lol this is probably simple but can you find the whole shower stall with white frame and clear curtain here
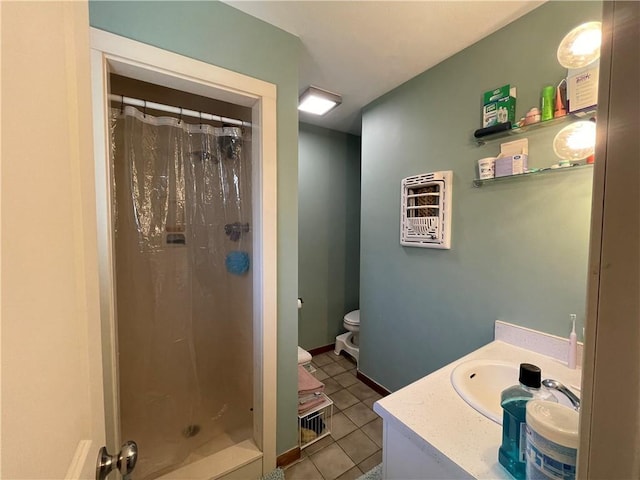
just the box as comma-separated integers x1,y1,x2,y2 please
90,28,277,480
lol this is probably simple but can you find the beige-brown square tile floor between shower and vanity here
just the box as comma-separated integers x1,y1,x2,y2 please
284,352,382,480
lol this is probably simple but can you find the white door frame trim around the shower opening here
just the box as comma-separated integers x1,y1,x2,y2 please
90,28,277,472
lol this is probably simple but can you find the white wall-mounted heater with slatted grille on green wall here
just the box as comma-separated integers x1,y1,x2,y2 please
400,171,453,249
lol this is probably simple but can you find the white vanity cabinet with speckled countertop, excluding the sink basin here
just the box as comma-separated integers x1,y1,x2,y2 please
373,324,581,480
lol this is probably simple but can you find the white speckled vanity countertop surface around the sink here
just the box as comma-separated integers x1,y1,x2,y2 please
373,340,581,479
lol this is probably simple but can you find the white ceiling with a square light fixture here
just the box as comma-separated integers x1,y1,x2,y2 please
225,0,544,135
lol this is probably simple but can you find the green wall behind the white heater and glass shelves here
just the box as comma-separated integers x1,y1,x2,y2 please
360,2,602,390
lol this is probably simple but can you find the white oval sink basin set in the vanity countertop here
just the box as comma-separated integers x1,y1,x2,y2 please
451,360,519,425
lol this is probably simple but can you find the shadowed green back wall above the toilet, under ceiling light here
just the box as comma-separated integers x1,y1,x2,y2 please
298,123,360,349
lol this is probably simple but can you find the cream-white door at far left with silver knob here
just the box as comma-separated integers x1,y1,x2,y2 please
0,1,111,479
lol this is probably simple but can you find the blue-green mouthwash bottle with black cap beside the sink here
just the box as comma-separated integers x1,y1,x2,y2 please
498,363,557,480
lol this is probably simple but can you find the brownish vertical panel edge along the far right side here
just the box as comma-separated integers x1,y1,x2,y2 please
578,2,640,479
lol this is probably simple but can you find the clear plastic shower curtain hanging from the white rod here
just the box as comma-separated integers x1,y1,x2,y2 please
112,107,253,479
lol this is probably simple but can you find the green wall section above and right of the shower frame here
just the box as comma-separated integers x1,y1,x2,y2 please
89,1,300,454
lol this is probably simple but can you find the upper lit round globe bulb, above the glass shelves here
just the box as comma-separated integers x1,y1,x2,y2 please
557,22,602,69
